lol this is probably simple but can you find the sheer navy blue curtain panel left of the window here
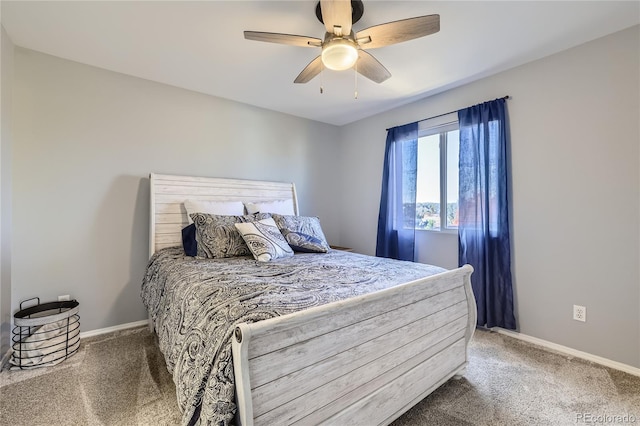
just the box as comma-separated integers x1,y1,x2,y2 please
376,122,418,261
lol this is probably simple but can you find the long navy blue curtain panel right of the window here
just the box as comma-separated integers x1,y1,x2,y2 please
458,99,516,330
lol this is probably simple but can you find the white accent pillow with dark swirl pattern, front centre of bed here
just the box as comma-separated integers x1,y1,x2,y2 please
235,218,293,262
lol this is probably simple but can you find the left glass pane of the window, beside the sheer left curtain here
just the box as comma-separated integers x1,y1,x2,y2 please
416,134,440,229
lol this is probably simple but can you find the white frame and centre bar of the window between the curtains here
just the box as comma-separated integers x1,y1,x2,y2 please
415,113,460,234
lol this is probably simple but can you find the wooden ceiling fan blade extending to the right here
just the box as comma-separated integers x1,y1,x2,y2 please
356,15,440,49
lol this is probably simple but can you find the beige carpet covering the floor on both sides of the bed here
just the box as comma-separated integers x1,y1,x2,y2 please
0,328,640,426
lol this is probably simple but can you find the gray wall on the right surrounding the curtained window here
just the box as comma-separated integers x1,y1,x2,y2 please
340,26,640,367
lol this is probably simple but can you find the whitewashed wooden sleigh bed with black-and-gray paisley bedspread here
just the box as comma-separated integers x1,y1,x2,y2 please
142,173,476,425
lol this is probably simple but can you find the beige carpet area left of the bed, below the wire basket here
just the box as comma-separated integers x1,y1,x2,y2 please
0,328,180,426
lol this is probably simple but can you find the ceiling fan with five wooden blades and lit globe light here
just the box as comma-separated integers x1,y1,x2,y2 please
244,0,440,83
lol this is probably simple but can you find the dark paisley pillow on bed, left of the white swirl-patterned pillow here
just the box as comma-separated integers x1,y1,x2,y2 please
191,213,271,259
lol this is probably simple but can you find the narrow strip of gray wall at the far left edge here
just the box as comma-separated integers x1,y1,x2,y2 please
0,26,13,360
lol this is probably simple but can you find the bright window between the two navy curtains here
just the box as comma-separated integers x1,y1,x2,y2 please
415,121,460,231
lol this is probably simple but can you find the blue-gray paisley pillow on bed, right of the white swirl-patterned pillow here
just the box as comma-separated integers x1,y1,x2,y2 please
272,214,329,253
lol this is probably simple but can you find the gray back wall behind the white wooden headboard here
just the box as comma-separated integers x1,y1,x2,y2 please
12,47,340,331
